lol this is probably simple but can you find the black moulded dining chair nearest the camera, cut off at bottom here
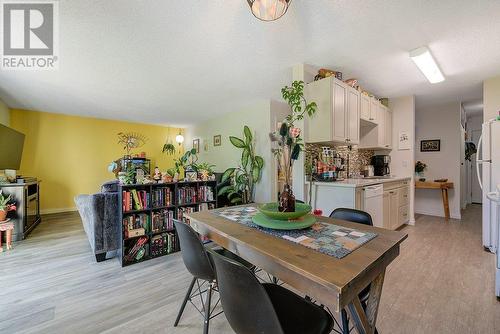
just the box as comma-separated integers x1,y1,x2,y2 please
210,251,333,334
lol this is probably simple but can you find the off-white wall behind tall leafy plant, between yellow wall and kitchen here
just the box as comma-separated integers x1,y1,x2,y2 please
185,100,275,202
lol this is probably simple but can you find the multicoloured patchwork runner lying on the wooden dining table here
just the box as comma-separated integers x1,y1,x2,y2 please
211,206,377,259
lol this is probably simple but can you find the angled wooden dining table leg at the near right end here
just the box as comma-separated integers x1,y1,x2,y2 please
347,270,385,334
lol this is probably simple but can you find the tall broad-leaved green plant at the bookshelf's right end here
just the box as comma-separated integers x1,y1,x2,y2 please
219,125,264,204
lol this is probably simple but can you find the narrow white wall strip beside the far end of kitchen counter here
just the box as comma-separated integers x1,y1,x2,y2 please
389,96,415,225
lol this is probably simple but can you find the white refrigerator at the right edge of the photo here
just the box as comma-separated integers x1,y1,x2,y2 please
476,120,500,296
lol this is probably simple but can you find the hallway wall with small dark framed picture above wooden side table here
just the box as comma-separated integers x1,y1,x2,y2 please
415,103,461,219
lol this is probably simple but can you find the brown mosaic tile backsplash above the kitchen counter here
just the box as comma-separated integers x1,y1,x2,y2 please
305,144,374,178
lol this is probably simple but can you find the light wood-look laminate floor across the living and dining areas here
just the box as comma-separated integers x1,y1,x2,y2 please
0,206,500,334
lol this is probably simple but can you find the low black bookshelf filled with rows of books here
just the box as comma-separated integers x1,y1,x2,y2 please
119,181,217,267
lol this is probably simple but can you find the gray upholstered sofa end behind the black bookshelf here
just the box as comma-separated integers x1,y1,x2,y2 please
75,181,121,262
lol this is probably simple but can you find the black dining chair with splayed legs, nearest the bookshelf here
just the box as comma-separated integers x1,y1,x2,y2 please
174,220,254,334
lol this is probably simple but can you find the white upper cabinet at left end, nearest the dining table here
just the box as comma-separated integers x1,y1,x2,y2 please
306,77,360,145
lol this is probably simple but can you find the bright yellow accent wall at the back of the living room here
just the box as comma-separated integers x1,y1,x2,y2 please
10,109,184,213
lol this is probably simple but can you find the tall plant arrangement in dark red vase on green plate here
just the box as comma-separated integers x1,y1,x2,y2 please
269,81,317,212
